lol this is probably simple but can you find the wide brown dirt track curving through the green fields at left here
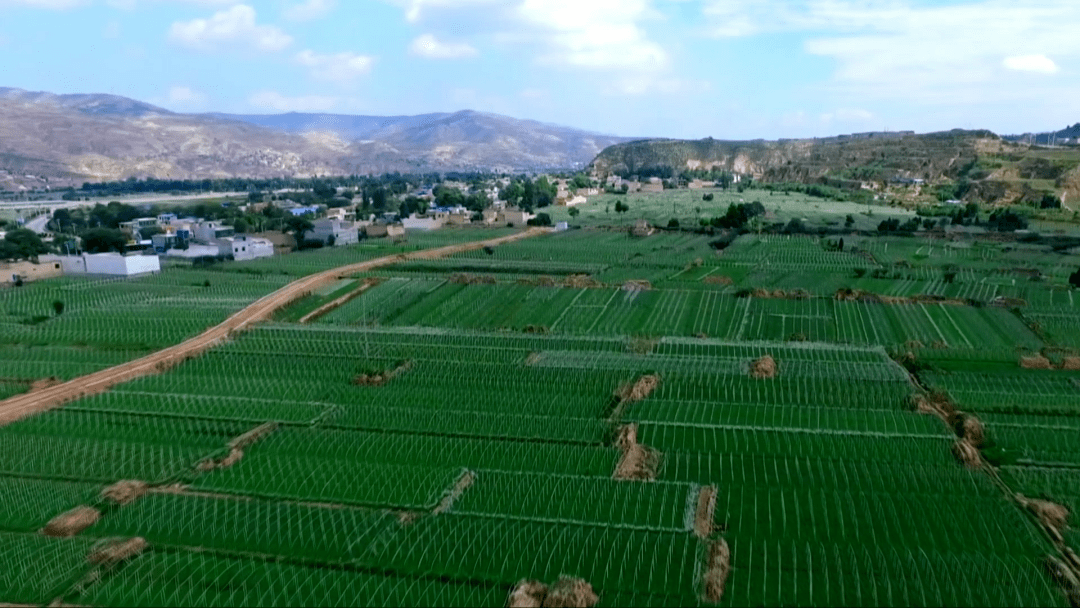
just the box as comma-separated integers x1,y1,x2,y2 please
0,228,549,427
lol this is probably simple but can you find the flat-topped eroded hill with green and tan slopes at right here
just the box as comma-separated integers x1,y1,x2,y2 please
592,130,1080,204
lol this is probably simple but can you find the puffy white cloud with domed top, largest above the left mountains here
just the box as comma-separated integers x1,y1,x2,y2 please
168,4,293,52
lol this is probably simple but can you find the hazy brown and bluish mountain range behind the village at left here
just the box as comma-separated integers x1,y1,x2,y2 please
0,87,630,190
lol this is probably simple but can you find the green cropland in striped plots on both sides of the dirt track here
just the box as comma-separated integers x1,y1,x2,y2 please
0,226,1080,606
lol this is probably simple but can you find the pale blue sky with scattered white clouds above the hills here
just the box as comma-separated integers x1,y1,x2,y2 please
0,0,1080,139
